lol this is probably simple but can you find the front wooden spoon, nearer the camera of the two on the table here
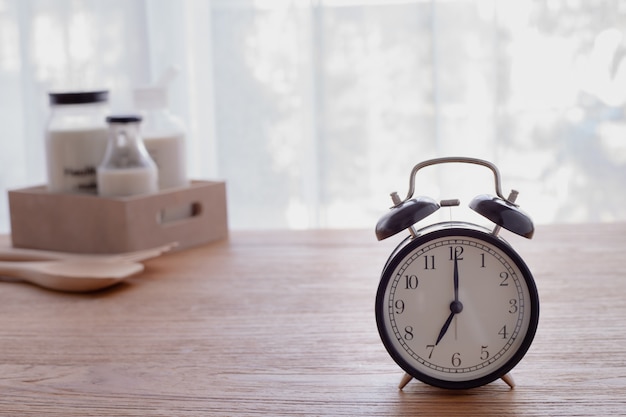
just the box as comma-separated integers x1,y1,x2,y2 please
0,260,144,292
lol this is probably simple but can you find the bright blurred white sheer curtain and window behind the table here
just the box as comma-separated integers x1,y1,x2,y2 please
0,0,626,233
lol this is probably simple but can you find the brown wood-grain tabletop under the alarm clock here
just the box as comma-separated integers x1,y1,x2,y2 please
0,224,626,417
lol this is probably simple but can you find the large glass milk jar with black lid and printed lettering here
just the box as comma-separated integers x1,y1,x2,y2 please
46,90,109,194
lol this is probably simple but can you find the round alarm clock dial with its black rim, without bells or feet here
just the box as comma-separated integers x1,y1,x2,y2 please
376,225,539,388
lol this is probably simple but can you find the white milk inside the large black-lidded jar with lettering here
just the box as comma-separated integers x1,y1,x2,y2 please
46,126,108,193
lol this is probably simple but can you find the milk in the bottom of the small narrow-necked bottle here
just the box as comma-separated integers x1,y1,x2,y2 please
98,167,158,197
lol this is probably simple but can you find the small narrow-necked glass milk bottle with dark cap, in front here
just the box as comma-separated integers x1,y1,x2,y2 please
97,115,158,197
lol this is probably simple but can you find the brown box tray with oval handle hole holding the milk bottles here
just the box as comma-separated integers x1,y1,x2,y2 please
9,181,228,253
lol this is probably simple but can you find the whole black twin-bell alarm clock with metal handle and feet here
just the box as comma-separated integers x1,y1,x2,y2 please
375,157,539,389
